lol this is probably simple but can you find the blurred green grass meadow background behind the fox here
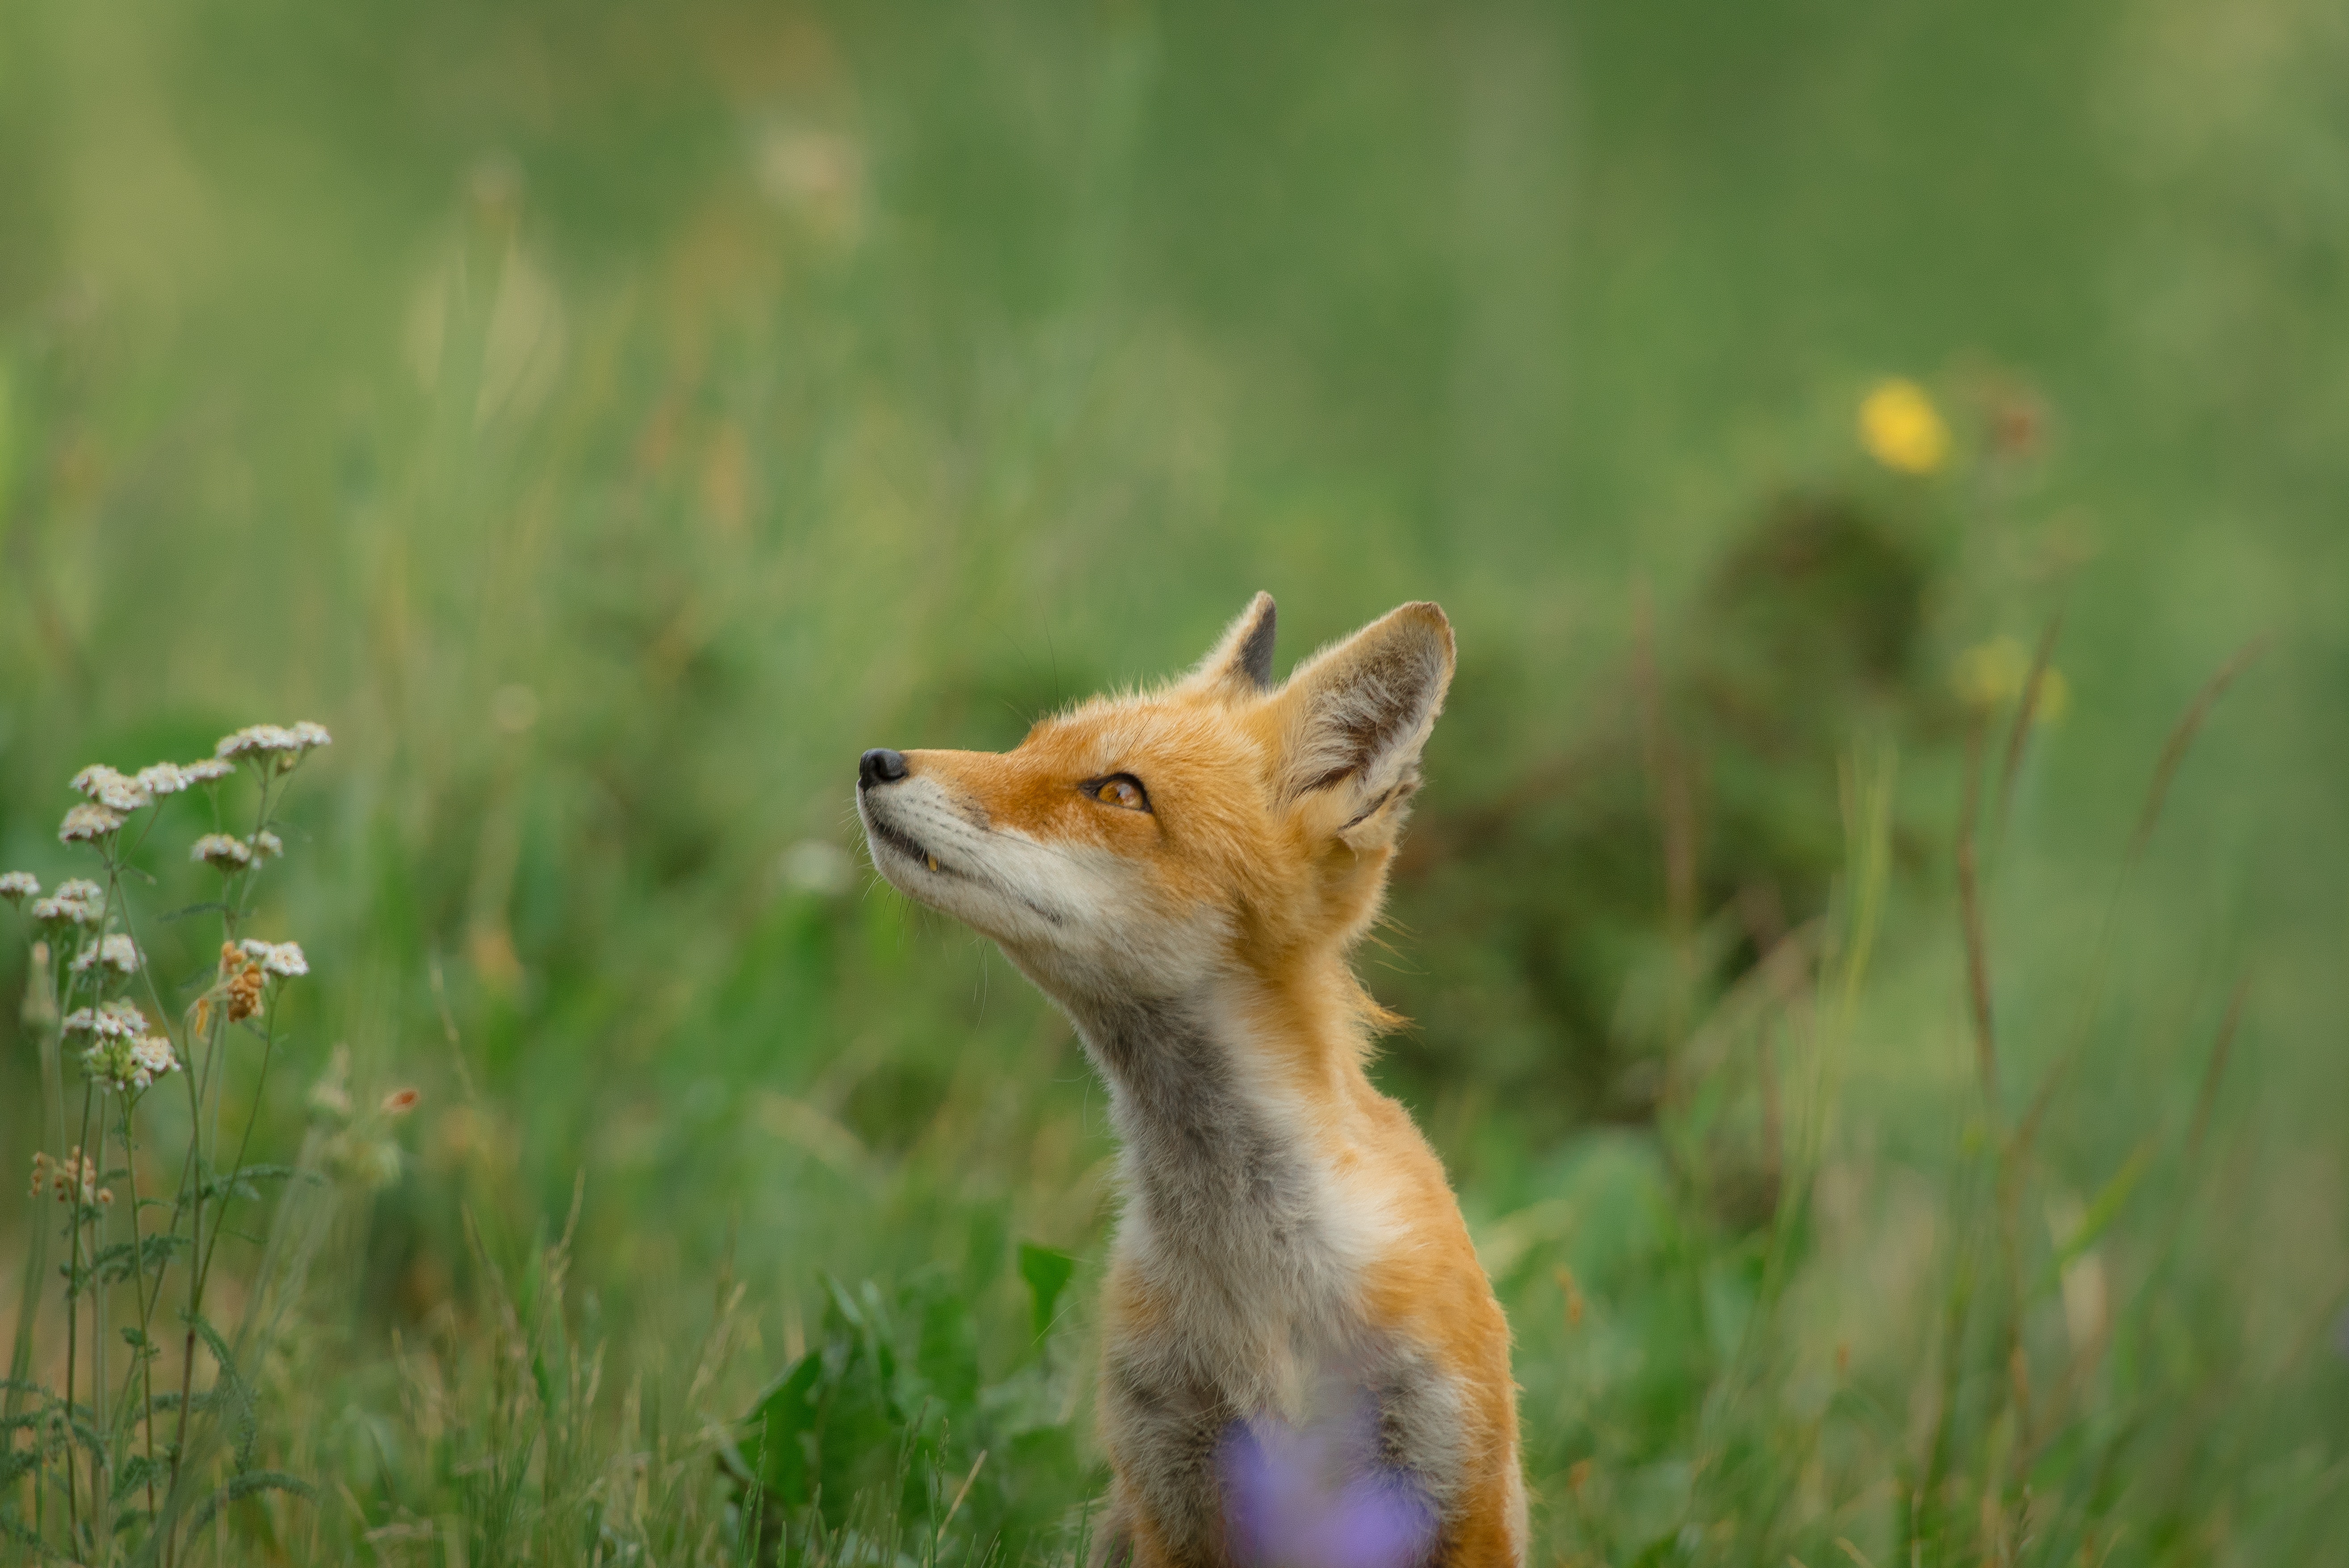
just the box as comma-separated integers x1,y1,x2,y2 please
0,0,2349,1568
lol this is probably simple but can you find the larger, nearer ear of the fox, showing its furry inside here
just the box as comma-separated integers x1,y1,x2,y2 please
1280,603,1454,840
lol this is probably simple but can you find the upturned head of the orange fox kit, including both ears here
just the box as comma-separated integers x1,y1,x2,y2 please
857,594,1454,1009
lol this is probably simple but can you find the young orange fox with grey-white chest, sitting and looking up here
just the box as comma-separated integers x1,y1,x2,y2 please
857,594,1524,1568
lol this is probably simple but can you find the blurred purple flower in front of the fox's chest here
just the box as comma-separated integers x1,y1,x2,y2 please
1217,1404,1435,1568
